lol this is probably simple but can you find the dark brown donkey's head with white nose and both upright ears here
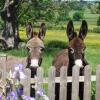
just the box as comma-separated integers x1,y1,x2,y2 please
67,20,88,67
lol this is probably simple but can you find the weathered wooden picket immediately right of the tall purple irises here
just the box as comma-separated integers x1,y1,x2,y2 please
23,69,31,96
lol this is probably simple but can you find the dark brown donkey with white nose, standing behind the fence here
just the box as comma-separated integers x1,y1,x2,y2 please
52,20,88,100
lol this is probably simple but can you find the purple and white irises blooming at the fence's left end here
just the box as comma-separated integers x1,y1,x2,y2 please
0,64,49,100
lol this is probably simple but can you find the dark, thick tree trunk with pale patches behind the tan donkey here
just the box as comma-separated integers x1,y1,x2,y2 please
1,0,19,48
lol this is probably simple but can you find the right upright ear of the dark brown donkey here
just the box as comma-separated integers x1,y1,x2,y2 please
79,20,88,40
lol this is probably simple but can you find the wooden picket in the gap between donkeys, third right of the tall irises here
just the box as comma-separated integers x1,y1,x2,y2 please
48,67,55,100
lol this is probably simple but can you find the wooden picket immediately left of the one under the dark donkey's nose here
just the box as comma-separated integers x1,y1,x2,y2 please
59,66,67,100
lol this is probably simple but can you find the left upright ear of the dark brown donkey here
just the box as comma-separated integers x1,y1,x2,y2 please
66,20,77,41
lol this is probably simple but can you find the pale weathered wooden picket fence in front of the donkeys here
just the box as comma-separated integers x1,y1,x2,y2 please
2,56,100,100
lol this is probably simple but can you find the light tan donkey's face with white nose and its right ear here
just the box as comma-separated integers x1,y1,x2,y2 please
26,23,46,67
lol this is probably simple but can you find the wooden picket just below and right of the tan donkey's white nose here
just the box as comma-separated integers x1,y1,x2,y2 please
35,67,43,100
